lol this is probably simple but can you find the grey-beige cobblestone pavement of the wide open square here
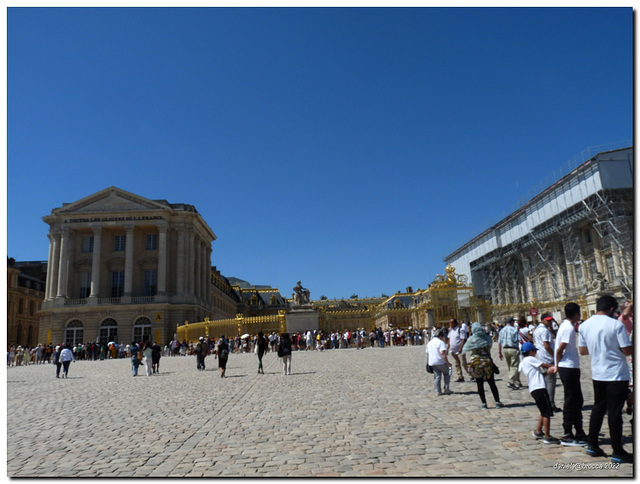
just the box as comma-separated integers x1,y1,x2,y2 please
7,346,633,477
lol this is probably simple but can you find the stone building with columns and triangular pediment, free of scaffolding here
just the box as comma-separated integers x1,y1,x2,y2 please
39,187,225,344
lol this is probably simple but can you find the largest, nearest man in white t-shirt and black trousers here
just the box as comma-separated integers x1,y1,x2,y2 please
578,295,633,463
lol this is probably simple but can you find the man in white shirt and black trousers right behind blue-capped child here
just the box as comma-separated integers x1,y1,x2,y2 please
556,303,587,446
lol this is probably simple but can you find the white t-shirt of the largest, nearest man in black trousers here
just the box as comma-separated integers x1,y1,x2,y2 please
578,314,631,381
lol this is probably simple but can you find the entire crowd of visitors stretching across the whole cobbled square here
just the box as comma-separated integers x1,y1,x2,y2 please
7,296,633,462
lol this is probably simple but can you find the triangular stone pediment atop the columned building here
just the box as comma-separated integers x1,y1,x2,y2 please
53,187,172,215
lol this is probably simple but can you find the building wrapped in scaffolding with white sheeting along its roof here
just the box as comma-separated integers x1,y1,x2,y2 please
444,147,634,320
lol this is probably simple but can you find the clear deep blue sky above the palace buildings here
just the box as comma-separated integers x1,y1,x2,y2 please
7,8,633,299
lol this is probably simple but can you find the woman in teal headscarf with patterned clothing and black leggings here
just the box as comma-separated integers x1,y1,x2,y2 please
462,323,504,410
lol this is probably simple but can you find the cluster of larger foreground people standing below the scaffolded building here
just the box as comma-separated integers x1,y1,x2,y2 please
426,295,633,463
